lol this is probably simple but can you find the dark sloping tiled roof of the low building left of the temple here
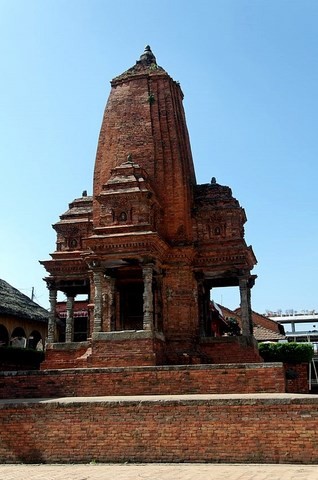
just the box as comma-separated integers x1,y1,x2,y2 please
0,279,49,323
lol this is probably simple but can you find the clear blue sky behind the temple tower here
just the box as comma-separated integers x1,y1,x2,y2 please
0,0,318,313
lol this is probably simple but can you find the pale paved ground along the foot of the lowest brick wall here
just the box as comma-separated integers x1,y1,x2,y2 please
0,462,317,480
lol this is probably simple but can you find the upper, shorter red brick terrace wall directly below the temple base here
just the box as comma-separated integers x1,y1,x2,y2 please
0,363,285,399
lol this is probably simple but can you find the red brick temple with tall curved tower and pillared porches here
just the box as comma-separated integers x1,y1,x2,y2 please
41,46,260,368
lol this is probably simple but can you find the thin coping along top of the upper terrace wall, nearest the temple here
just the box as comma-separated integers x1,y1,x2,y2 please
0,362,283,377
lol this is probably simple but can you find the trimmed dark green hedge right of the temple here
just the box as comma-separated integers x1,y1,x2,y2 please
259,342,314,363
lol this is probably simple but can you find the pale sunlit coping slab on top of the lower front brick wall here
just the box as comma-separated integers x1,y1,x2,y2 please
0,393,318,409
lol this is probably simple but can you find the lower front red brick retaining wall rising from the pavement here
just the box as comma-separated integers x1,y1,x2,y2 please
0,395,318,464
